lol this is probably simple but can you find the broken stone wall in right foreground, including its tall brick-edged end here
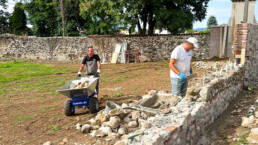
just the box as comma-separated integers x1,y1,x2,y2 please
114,24,258,145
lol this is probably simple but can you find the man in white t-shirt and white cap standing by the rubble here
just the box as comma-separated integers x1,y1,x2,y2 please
169,37,198,97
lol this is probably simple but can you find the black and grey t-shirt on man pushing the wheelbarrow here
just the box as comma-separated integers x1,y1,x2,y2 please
82,54,100,75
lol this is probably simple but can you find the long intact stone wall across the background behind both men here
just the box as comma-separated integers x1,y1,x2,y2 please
0,34,209,62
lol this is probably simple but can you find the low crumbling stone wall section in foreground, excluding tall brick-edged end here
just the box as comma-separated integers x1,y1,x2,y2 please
116,67,244,145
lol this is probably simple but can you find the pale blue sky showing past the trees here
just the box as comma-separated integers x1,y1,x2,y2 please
2,0,258,29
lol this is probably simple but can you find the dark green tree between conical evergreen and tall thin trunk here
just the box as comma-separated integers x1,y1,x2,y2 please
26,0,62,37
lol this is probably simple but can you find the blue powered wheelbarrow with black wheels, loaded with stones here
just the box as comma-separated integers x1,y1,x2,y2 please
56,77,99,116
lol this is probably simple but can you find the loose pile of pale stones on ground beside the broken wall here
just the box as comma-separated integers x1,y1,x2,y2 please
75,90,180,139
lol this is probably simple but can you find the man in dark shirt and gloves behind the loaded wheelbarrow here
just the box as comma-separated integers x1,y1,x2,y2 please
78,46,101,97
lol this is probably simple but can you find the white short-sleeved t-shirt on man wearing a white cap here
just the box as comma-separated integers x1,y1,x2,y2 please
170,45,192,78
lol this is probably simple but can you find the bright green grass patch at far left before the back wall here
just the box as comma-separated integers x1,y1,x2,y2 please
0,61,70,82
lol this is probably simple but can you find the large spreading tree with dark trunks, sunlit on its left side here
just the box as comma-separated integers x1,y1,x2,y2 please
80,0,209,35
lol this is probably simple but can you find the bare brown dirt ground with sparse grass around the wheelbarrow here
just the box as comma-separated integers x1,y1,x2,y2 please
0,61,222,145
